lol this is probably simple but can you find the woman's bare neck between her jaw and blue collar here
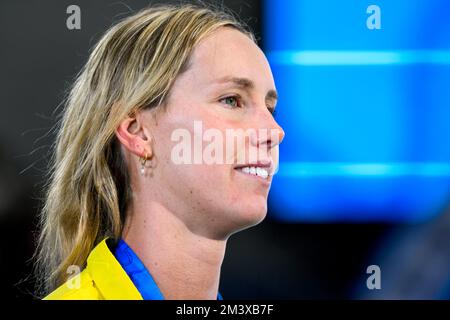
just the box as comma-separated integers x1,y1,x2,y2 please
122,202,226,300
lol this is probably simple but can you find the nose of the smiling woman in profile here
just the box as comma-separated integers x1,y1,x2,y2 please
252,108,285,149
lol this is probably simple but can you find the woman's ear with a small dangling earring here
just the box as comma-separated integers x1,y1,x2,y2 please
115,111,153,158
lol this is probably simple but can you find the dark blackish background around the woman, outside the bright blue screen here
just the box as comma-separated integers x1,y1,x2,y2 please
0,0,450,299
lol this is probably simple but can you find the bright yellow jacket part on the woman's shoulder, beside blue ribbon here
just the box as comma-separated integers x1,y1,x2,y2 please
44,239,142,300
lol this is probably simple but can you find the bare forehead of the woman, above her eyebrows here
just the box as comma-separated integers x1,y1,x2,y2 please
183,27,275,90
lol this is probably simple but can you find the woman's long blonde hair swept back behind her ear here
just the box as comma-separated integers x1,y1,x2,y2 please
35,5,255,294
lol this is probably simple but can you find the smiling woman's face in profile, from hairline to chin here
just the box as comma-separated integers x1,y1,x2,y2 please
145,27,284,239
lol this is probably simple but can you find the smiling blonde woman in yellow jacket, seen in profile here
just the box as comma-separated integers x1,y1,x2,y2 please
37,5,284,299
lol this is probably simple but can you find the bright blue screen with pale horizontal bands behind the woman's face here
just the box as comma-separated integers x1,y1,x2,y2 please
263,0,450,222
